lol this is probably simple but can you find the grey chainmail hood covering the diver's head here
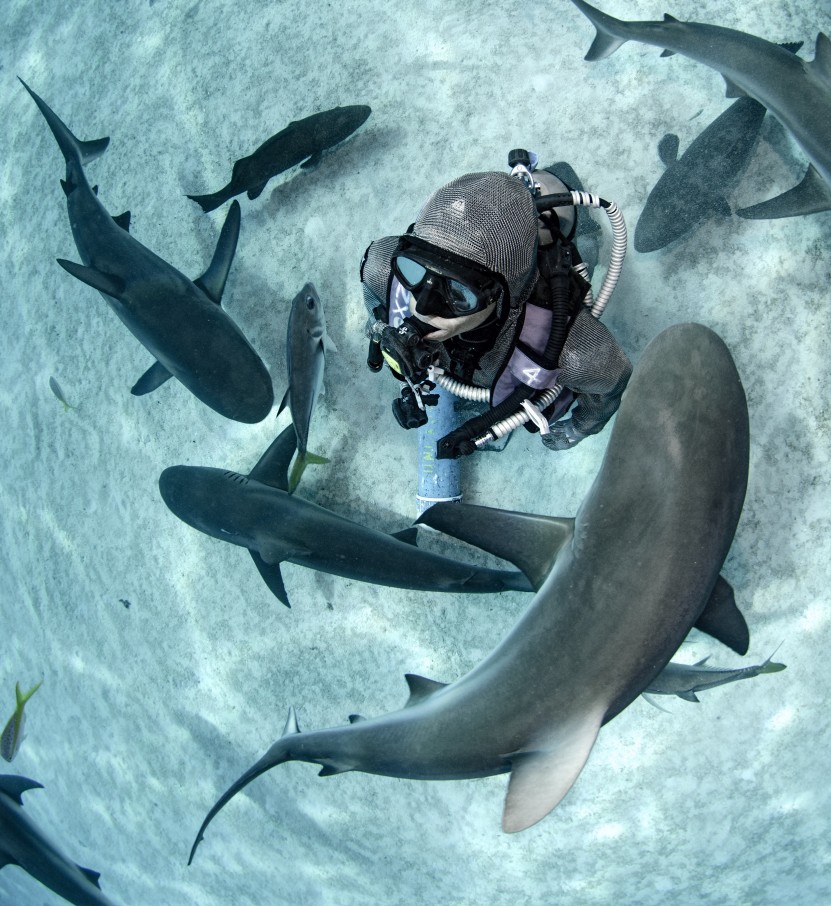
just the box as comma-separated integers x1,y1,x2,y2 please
413,172,538,308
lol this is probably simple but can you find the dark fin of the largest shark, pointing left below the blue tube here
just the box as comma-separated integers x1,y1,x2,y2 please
416,503,574,589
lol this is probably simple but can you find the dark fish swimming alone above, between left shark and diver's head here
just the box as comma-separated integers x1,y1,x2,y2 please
188,104,372,211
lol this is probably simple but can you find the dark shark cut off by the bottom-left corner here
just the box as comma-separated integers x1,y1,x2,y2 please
0,774,120,906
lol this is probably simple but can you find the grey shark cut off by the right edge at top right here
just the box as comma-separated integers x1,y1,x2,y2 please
572,0,831,219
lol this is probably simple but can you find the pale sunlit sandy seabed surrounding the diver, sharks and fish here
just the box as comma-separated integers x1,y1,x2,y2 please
0,0,831,906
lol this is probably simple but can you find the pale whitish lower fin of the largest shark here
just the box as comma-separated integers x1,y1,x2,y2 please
502,707,606,834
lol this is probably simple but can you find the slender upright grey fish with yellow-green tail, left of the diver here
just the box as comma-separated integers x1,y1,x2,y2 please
278,283,337,493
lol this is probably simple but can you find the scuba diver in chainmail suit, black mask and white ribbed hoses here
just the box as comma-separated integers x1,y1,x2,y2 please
360,149,632,459
